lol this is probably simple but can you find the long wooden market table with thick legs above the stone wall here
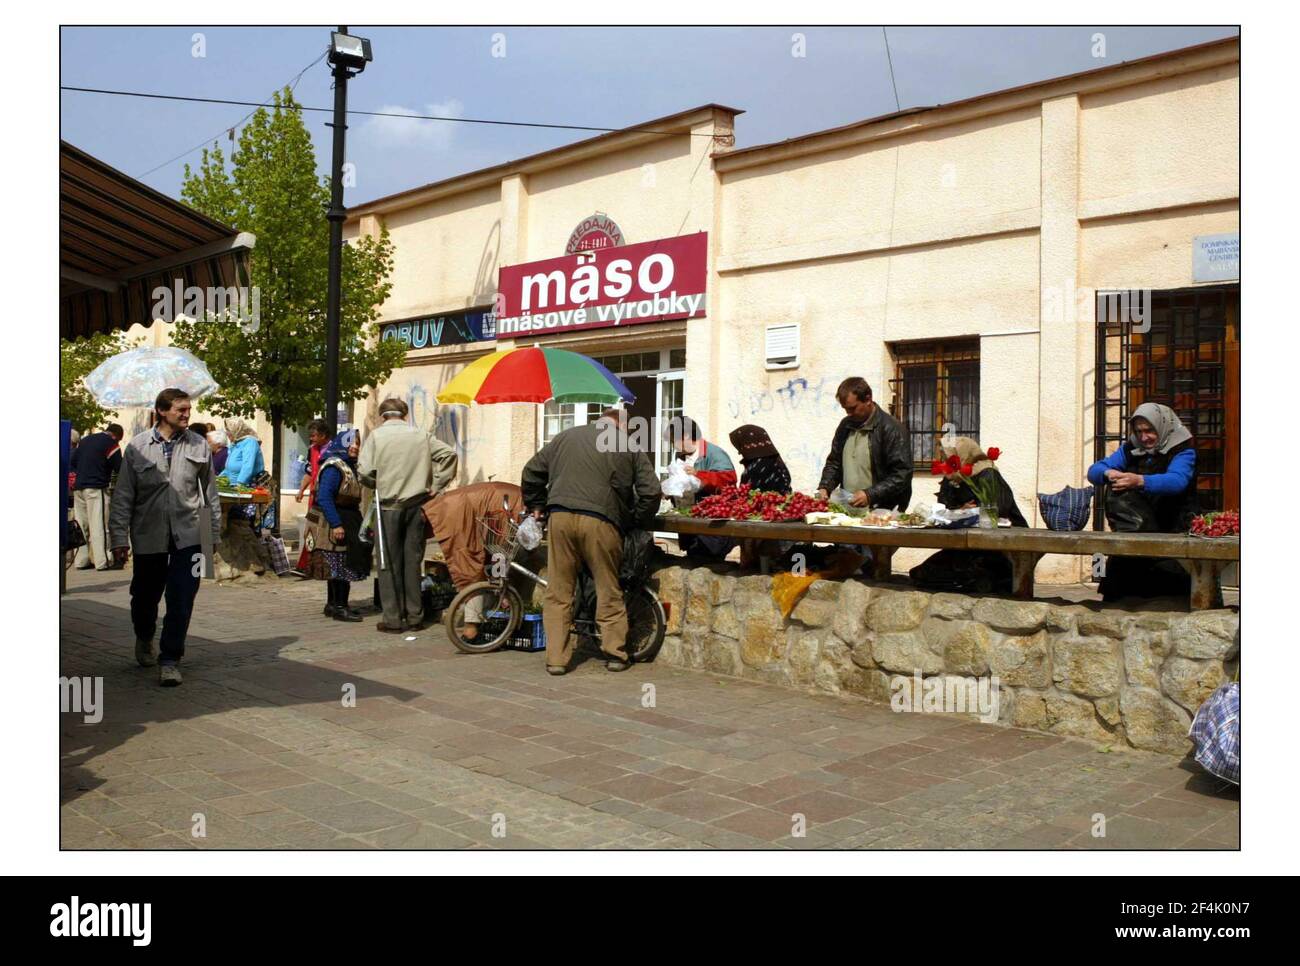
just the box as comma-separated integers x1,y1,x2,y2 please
654,514,1242,610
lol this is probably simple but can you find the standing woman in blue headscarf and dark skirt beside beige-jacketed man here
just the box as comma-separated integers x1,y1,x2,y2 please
306,429,371,623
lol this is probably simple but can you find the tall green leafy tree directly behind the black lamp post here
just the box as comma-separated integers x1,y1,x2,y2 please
172,87,406,491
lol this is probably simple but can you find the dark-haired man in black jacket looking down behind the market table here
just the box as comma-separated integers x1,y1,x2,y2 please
818,376,913,510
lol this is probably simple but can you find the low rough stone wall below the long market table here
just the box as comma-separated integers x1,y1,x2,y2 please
655,562,1239,754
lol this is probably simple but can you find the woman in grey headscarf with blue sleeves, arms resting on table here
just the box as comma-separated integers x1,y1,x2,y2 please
1088,403,1200,601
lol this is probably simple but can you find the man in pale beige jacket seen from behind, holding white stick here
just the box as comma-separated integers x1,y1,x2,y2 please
356,399,458,633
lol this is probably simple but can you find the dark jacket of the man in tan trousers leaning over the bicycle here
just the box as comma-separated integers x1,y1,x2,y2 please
523,419,660,533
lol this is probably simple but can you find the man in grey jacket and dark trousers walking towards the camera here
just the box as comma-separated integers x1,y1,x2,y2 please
108,389,221,686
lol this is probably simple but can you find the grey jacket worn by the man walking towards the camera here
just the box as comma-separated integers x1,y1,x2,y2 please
108,429,221,554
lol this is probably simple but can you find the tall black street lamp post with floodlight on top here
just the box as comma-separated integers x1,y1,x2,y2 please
324,26,371,436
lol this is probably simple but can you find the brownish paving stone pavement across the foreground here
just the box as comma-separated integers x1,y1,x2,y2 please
60,569,1239,849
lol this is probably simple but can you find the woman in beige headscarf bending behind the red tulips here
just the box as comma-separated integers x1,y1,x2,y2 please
911,436,1030,594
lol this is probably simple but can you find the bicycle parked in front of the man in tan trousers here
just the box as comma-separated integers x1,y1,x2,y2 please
443,508,668,662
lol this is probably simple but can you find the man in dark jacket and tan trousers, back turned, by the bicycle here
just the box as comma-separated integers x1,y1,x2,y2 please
521,410,659,675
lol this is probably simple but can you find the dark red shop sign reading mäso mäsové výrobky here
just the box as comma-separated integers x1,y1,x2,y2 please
497,231,709,339
